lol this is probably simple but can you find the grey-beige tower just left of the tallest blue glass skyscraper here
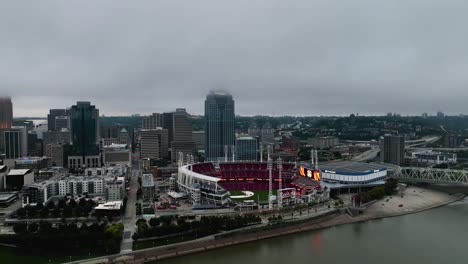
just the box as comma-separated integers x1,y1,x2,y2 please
169,108,195,161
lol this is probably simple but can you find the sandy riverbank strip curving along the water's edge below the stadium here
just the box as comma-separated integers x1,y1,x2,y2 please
77,187,463,263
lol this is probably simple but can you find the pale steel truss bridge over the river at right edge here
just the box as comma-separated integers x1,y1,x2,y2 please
392,167,468,186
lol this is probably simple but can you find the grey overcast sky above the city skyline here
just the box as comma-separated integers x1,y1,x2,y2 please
0,0,468,117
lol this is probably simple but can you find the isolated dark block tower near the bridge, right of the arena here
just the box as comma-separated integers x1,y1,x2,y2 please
380,135,405,165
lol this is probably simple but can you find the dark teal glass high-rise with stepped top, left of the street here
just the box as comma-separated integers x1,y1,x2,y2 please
69,102,99,159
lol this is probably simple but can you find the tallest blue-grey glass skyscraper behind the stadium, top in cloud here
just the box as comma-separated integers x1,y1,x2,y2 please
205,92,236,161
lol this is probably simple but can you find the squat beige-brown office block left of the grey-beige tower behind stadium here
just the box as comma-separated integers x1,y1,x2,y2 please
140,128,169,159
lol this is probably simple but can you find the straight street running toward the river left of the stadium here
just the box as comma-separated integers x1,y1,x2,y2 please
120,155,141,254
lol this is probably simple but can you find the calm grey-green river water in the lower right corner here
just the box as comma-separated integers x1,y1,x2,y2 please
158,202,468,264
